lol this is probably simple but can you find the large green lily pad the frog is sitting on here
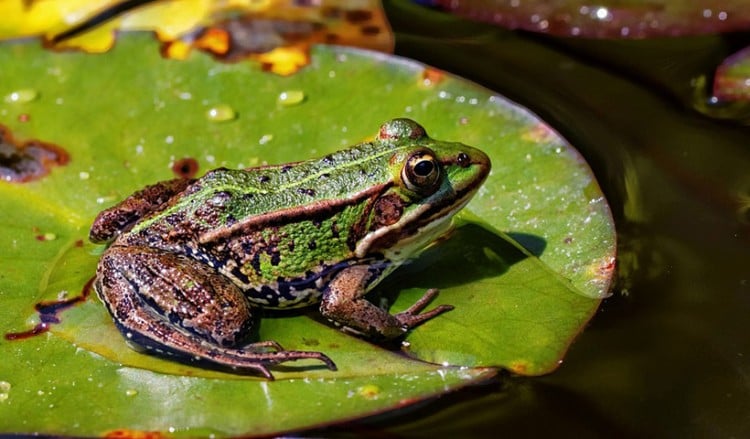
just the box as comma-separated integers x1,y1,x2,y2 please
0,35,615,436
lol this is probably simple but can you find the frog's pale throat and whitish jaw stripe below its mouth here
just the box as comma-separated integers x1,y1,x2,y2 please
354,190,475,262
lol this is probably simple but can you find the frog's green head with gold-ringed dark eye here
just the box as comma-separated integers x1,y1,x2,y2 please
356,119,490,261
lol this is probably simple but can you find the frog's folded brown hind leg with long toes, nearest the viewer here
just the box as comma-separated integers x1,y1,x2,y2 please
94,246,336,379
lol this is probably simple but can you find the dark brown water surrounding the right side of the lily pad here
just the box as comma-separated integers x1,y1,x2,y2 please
327,1,750,437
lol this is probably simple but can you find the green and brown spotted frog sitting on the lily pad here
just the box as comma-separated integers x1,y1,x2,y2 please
89,118,491,380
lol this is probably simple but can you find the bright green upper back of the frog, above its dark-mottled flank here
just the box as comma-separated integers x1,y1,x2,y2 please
133,142,398,237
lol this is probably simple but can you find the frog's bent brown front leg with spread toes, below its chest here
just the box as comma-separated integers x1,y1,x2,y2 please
320,265,453,339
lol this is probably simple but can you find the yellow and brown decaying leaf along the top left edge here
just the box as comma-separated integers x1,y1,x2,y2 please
0,0,393,75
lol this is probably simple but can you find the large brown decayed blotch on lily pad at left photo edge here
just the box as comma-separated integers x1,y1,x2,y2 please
0,125,70,183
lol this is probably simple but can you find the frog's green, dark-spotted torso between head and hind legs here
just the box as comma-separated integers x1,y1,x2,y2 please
122,142,402,307
